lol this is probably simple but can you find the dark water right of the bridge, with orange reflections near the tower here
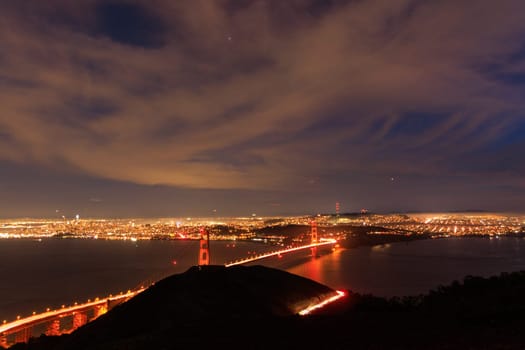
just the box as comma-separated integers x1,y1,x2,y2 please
288,238,525,296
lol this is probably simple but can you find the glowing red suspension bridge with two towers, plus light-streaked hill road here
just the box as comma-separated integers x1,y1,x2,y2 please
0,221,344,348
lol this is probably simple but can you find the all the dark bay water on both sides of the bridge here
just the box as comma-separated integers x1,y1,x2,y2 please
0,238,525,321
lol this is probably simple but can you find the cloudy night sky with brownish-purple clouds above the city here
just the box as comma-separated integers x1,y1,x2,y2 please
0,0,525,217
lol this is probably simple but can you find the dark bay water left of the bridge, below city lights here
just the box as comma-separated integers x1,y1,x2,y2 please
0,239,274,322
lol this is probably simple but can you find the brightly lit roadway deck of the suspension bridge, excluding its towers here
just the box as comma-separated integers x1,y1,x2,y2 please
0,239,336,345
